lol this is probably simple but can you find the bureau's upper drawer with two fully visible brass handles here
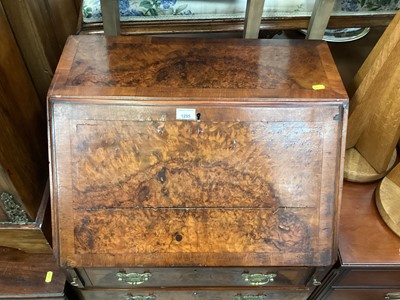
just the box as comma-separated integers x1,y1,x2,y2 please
81,267,313,287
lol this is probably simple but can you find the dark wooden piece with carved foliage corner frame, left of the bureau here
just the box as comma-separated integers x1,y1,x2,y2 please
0,2,51,253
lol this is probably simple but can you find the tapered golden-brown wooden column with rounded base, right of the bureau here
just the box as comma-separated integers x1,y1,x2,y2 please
345,13,400,182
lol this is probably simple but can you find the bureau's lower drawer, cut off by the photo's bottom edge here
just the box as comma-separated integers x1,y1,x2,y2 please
81,289,307,300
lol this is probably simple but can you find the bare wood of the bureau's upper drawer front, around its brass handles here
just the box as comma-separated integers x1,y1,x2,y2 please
80,267,315,288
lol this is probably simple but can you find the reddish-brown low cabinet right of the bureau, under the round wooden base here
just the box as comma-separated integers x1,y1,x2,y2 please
312,182,400,300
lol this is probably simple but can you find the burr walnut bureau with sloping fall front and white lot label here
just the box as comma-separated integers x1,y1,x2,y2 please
48,36,348,300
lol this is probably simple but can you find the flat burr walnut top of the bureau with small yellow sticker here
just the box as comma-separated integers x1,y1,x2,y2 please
49,36,347,102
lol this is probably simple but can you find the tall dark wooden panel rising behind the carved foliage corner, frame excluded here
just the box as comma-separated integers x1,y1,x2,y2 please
0,3,47,221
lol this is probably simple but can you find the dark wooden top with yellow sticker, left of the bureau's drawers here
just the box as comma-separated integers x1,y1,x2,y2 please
0,247,66,300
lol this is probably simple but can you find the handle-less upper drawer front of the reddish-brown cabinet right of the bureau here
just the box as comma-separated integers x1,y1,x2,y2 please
334,269,400,288
